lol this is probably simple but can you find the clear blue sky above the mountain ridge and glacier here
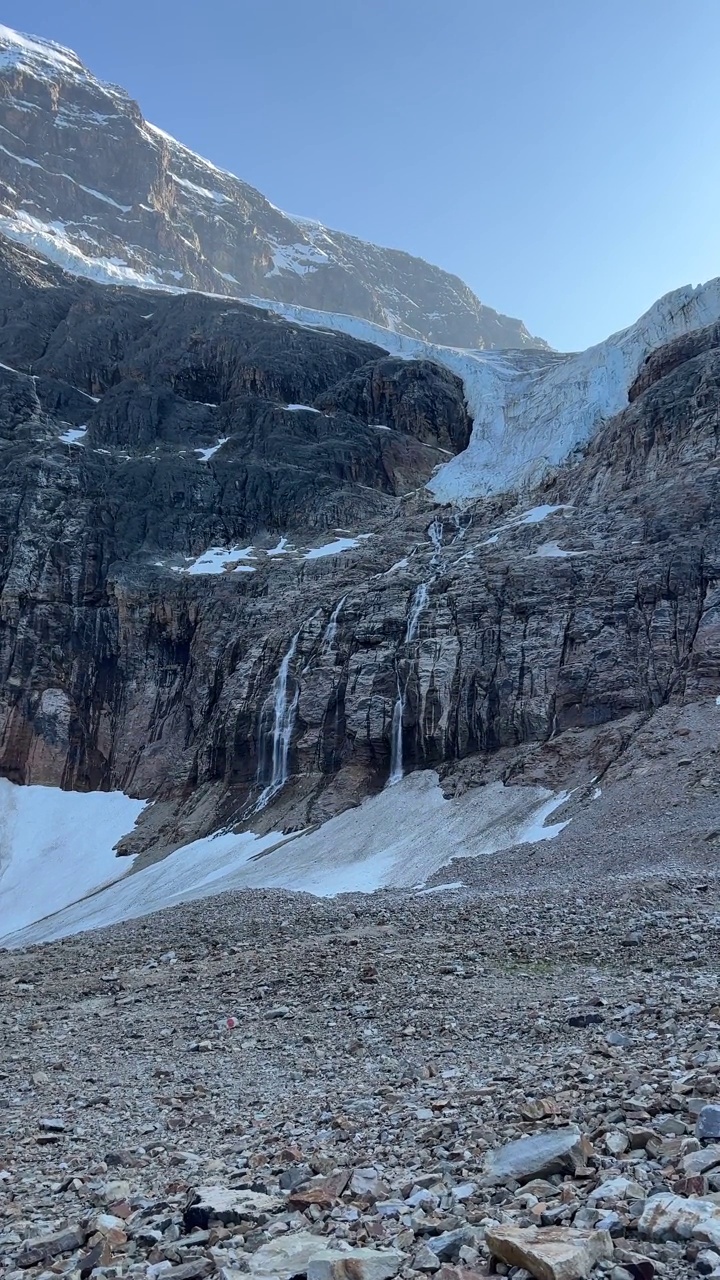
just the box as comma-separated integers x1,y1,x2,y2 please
0,0,720,349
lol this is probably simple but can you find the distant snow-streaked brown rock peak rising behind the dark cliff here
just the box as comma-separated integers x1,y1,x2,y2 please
0,27,547,348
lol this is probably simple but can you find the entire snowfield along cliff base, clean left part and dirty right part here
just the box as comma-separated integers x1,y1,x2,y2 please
0,769,568,946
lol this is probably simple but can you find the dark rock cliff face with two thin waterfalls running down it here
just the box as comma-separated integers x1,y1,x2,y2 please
0,246,720,847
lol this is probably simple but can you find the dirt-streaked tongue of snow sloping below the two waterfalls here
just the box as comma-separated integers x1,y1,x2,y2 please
0,769,568,946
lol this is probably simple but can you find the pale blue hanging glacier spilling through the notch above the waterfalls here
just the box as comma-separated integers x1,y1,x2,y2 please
258,278,720,503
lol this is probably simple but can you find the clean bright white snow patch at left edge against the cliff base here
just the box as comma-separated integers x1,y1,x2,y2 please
0,778,145,934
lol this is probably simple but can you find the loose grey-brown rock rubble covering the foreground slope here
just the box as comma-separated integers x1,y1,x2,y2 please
0,859,720,1280
